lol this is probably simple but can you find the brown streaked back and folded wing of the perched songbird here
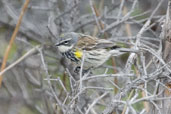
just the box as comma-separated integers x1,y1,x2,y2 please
76,34,118,50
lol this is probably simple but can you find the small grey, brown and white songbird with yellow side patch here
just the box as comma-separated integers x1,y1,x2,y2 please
56,32,135,69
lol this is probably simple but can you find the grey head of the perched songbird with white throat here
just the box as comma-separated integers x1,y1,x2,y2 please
55,32,79,53
